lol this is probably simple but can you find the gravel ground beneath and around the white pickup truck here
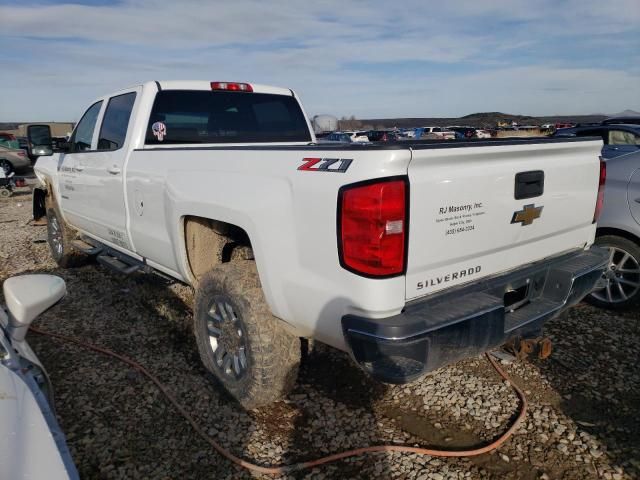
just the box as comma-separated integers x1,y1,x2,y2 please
0,191,640,480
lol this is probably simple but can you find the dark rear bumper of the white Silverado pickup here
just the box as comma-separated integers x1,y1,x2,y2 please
342,247,609,383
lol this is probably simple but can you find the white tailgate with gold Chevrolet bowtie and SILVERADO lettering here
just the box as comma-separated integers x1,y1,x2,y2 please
406,140,602,299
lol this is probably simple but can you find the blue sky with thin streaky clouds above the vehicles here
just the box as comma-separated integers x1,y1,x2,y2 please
0,0,640,121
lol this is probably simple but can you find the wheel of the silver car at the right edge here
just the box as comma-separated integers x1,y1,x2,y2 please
587,235,640,310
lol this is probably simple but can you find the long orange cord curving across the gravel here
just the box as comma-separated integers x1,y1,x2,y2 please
30,327,527,475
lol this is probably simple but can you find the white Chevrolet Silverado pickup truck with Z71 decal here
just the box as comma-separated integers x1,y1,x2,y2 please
30,81,607,408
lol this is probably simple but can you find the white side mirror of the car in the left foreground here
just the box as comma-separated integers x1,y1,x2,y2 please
2,275,67,342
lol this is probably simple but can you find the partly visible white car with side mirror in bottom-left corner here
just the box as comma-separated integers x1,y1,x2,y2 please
0,275,79,480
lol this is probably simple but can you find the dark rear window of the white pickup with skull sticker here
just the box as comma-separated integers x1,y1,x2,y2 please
146,90,311,145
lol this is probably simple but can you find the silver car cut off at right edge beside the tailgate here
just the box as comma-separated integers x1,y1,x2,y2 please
587,149,640,309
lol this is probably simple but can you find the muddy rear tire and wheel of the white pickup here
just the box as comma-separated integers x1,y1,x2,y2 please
194,260,300,410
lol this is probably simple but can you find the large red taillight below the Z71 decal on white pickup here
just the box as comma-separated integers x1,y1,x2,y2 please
338,177,409,278
